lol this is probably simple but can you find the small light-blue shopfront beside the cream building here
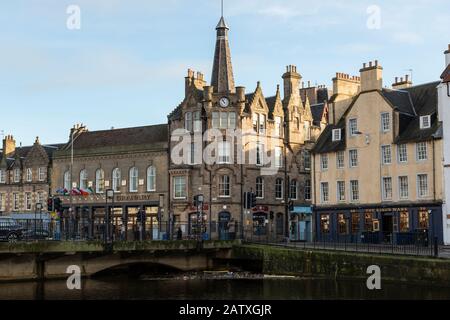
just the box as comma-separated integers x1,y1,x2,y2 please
289,206,312,242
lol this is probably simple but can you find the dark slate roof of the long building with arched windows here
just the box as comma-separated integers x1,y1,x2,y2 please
66,124,168,149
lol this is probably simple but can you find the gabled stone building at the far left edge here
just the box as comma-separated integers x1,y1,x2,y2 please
0,135,61,215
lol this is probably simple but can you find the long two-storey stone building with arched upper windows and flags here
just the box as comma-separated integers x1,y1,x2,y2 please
52,124,168,239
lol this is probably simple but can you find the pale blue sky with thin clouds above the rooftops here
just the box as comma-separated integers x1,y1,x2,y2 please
0,0,450,145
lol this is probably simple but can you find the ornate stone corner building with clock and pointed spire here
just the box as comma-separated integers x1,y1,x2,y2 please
168,17,328,239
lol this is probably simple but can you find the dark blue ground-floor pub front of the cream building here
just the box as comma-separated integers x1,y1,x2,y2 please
313,205,443,245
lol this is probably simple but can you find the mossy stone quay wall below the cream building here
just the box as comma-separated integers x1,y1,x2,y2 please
233,245,450,286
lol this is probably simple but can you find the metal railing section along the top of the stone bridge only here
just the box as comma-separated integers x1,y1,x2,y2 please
0,218,242,242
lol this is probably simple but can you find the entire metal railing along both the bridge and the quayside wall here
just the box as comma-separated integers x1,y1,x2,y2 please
0,218,439,256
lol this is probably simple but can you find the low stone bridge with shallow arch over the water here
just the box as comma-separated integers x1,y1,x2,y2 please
0,240,240,281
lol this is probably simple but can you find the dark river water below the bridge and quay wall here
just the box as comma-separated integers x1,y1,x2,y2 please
0,274,450,300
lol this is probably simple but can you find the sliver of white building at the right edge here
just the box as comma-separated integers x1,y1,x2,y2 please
437,44,450,244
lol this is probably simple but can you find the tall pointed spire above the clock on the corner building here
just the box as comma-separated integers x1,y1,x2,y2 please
211,0,235,93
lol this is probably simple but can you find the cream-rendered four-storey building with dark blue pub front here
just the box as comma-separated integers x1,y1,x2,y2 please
313,61,443,244
